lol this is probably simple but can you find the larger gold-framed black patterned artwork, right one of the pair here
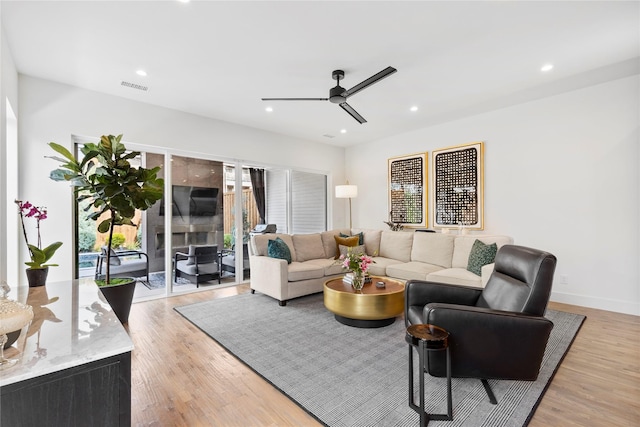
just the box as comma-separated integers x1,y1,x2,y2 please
431,142,484,230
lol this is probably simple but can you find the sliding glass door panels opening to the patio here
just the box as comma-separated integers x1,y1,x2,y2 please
75,139,327,301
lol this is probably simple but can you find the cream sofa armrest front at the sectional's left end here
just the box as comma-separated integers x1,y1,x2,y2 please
249,255,289,301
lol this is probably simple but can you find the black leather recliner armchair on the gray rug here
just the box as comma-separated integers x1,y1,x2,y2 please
404,245,556,403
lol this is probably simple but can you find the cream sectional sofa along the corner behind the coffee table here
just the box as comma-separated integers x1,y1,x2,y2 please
249,229,513,305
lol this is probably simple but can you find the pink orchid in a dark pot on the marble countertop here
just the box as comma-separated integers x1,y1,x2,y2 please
15,200,62,287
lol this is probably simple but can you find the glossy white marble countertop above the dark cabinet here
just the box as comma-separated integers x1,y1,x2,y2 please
0,279,133,386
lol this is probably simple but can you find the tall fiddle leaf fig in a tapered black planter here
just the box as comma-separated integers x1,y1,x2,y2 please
49,135,164,323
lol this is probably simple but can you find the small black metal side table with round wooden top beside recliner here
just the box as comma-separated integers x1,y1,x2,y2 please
405,324,453,427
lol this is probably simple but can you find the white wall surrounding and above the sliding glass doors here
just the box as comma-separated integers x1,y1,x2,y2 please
19,75,346,281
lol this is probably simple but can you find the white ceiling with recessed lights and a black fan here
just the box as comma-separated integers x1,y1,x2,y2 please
0,0,640,146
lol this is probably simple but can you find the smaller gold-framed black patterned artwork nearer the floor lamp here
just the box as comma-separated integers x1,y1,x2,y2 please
388,152,428,227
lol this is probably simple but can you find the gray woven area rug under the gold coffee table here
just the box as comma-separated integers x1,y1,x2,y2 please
175,294,585,427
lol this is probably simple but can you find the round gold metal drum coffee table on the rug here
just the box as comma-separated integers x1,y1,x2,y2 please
324,276,404,328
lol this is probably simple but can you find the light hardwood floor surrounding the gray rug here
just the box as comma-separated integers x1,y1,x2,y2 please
128,285,640,427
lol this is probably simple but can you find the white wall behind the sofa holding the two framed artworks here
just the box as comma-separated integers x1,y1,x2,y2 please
346,76,640,315
